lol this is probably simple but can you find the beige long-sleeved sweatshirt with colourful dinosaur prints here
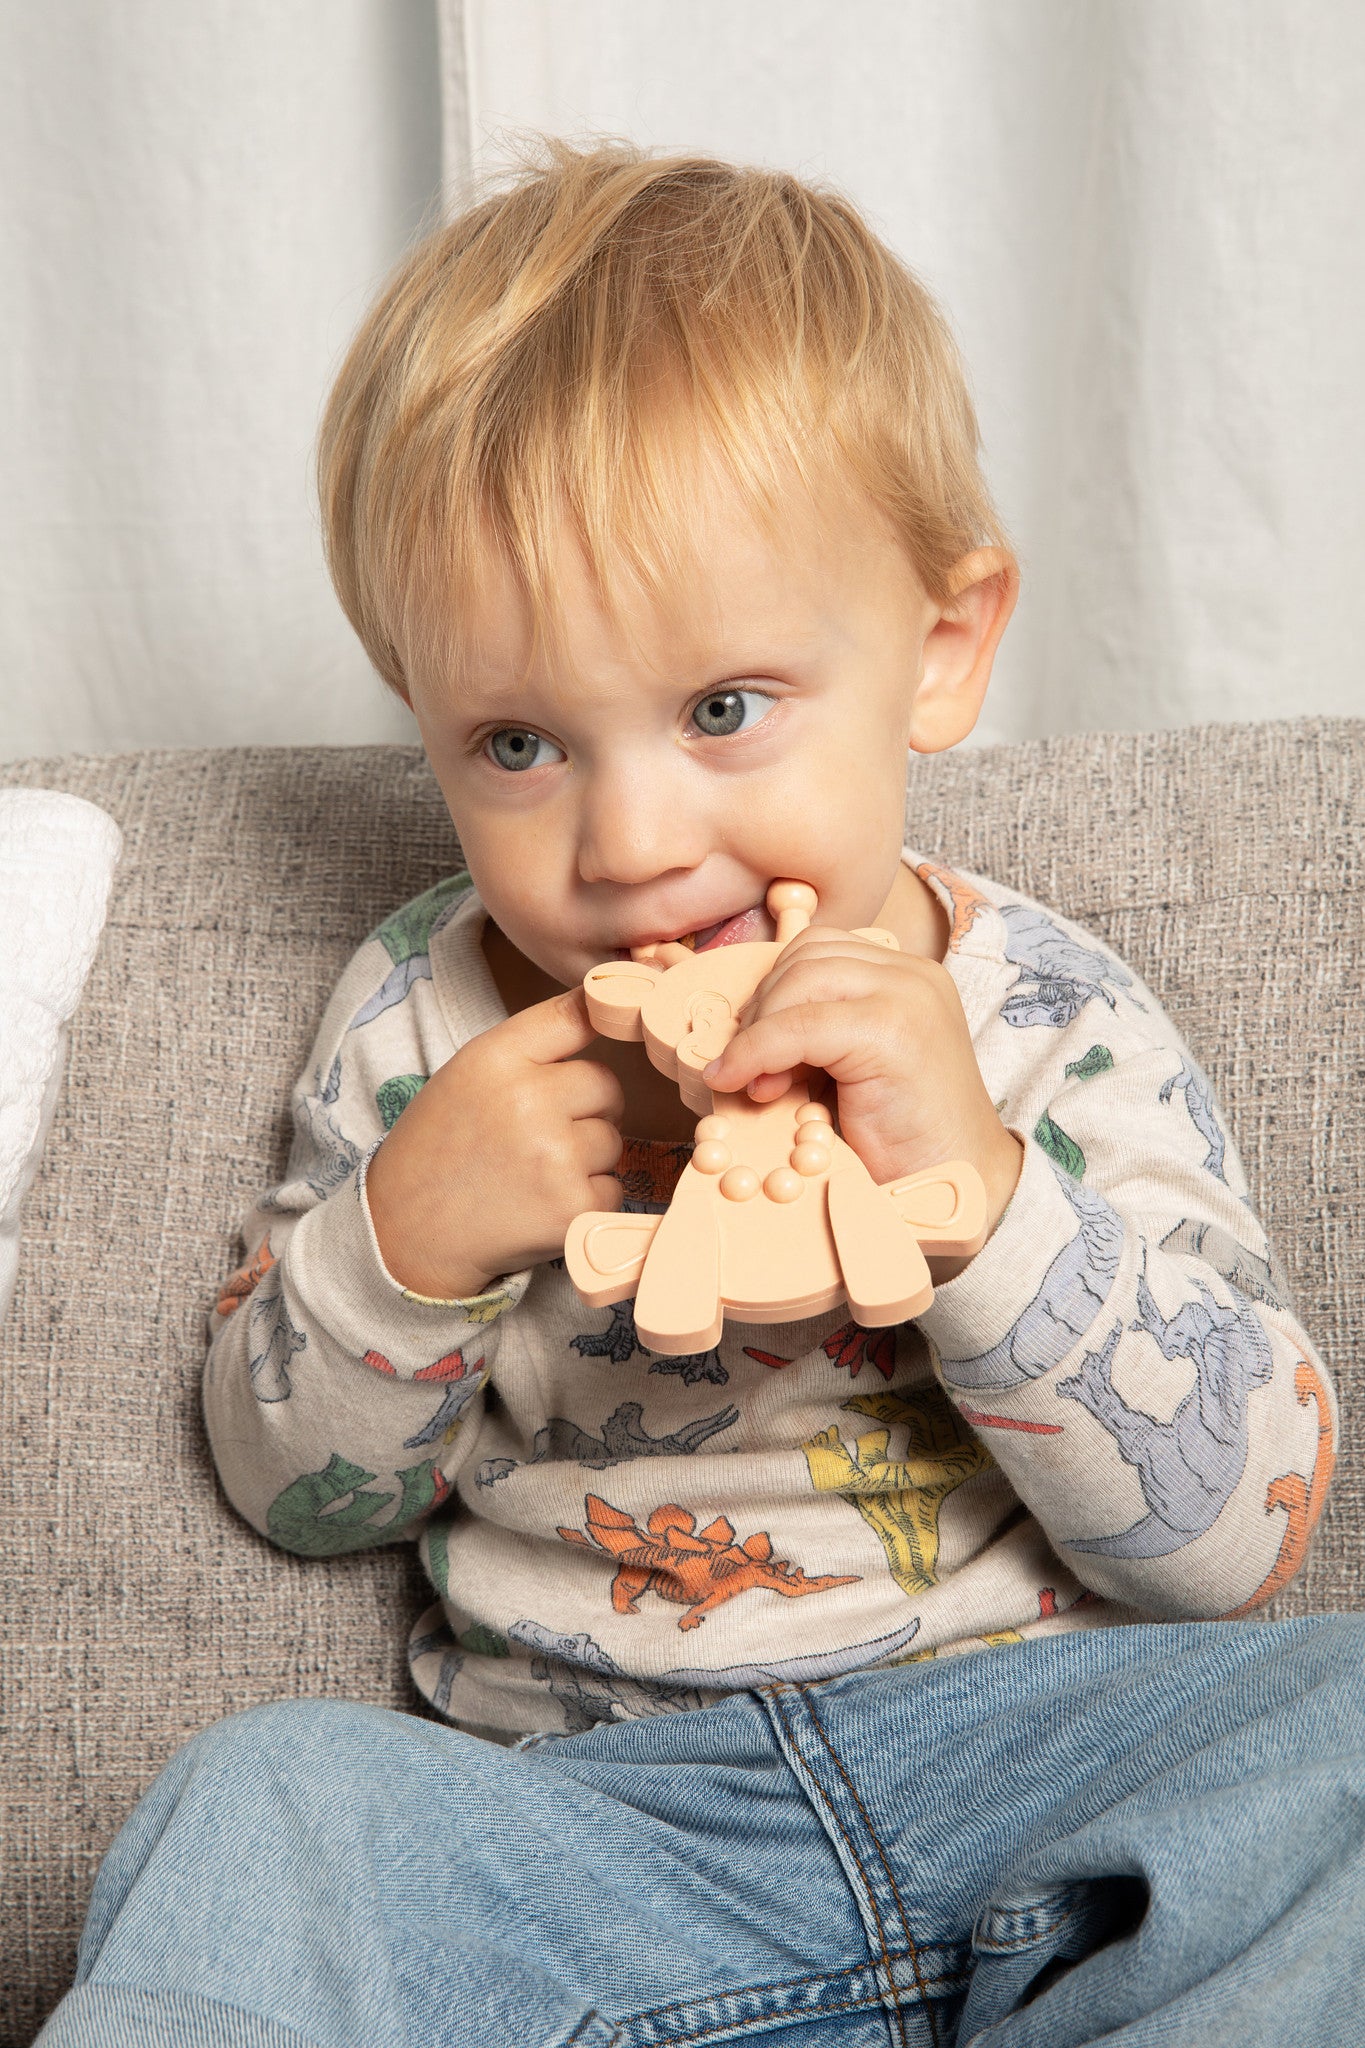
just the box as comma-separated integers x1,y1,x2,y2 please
205,850,1336,1737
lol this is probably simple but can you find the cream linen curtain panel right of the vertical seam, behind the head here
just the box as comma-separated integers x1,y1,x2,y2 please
440,0,1365,739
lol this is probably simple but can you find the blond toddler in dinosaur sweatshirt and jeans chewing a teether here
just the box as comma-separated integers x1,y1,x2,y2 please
45,143,1361,2048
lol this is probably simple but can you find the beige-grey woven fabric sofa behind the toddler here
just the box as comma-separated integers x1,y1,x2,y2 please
0,719,1365,2044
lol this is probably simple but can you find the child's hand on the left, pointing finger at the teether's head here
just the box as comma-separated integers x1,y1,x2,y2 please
366,987,626,1300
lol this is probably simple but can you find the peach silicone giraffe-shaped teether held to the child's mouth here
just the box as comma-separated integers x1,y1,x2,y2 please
565,881,986,1356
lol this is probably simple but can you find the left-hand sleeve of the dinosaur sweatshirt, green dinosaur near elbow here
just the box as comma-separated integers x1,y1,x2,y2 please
205,877,530,1556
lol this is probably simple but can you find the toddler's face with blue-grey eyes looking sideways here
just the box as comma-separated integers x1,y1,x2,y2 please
411,454,988,987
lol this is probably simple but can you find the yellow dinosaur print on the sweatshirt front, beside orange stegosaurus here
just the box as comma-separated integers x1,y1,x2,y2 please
802,1386,995,1597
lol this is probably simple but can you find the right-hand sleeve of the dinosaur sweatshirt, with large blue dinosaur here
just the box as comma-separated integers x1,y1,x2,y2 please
921,860,1336,1618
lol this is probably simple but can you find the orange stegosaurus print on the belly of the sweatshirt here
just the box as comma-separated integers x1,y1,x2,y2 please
559,1493,860,1628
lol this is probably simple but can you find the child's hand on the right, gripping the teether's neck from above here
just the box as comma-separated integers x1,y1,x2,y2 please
702,926,1023,1245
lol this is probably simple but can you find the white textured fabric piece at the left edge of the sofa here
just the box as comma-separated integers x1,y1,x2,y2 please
0,788,123,1317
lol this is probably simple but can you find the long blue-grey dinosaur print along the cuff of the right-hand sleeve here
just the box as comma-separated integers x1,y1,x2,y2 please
943,1161,1124,1389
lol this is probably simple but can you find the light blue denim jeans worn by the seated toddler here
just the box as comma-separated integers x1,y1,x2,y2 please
39,1616,1365,2048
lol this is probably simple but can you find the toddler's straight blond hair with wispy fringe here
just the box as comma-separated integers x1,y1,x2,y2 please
317,137,1005,692
